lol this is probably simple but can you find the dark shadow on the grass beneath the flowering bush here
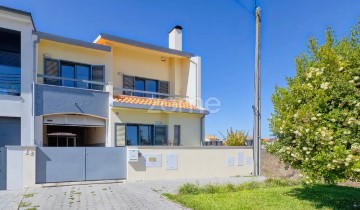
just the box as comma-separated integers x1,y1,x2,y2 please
287,185,360,209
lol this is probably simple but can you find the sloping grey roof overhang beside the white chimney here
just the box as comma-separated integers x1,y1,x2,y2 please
94,33,194,58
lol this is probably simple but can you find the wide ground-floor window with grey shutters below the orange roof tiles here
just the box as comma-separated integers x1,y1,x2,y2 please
125,124,167,145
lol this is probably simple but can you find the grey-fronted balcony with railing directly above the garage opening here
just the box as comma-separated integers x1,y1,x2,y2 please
35,74,109,119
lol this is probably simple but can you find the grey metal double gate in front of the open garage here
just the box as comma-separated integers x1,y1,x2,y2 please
36,147,126,183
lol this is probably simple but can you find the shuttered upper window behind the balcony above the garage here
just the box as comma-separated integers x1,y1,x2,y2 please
44,58,105,90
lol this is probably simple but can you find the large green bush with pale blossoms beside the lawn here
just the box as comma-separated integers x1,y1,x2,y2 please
268,23,360,183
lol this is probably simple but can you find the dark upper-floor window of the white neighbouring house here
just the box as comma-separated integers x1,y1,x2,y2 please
0,28,21,95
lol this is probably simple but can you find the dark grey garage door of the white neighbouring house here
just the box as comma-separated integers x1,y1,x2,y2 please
0,117,21,147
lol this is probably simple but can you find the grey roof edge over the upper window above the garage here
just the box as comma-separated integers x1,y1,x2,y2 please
33,31,111,52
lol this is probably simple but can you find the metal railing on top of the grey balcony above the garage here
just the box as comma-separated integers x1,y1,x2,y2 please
37,74,108,91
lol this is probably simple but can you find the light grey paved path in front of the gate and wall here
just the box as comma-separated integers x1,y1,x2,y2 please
0,177,264,210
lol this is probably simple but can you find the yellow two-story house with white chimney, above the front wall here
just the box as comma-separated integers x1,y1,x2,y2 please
34,26,207,147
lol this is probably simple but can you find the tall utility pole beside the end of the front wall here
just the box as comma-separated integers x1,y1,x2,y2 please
253,7,261,176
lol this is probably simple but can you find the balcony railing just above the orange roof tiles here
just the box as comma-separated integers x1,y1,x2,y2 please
114,87,189,101
